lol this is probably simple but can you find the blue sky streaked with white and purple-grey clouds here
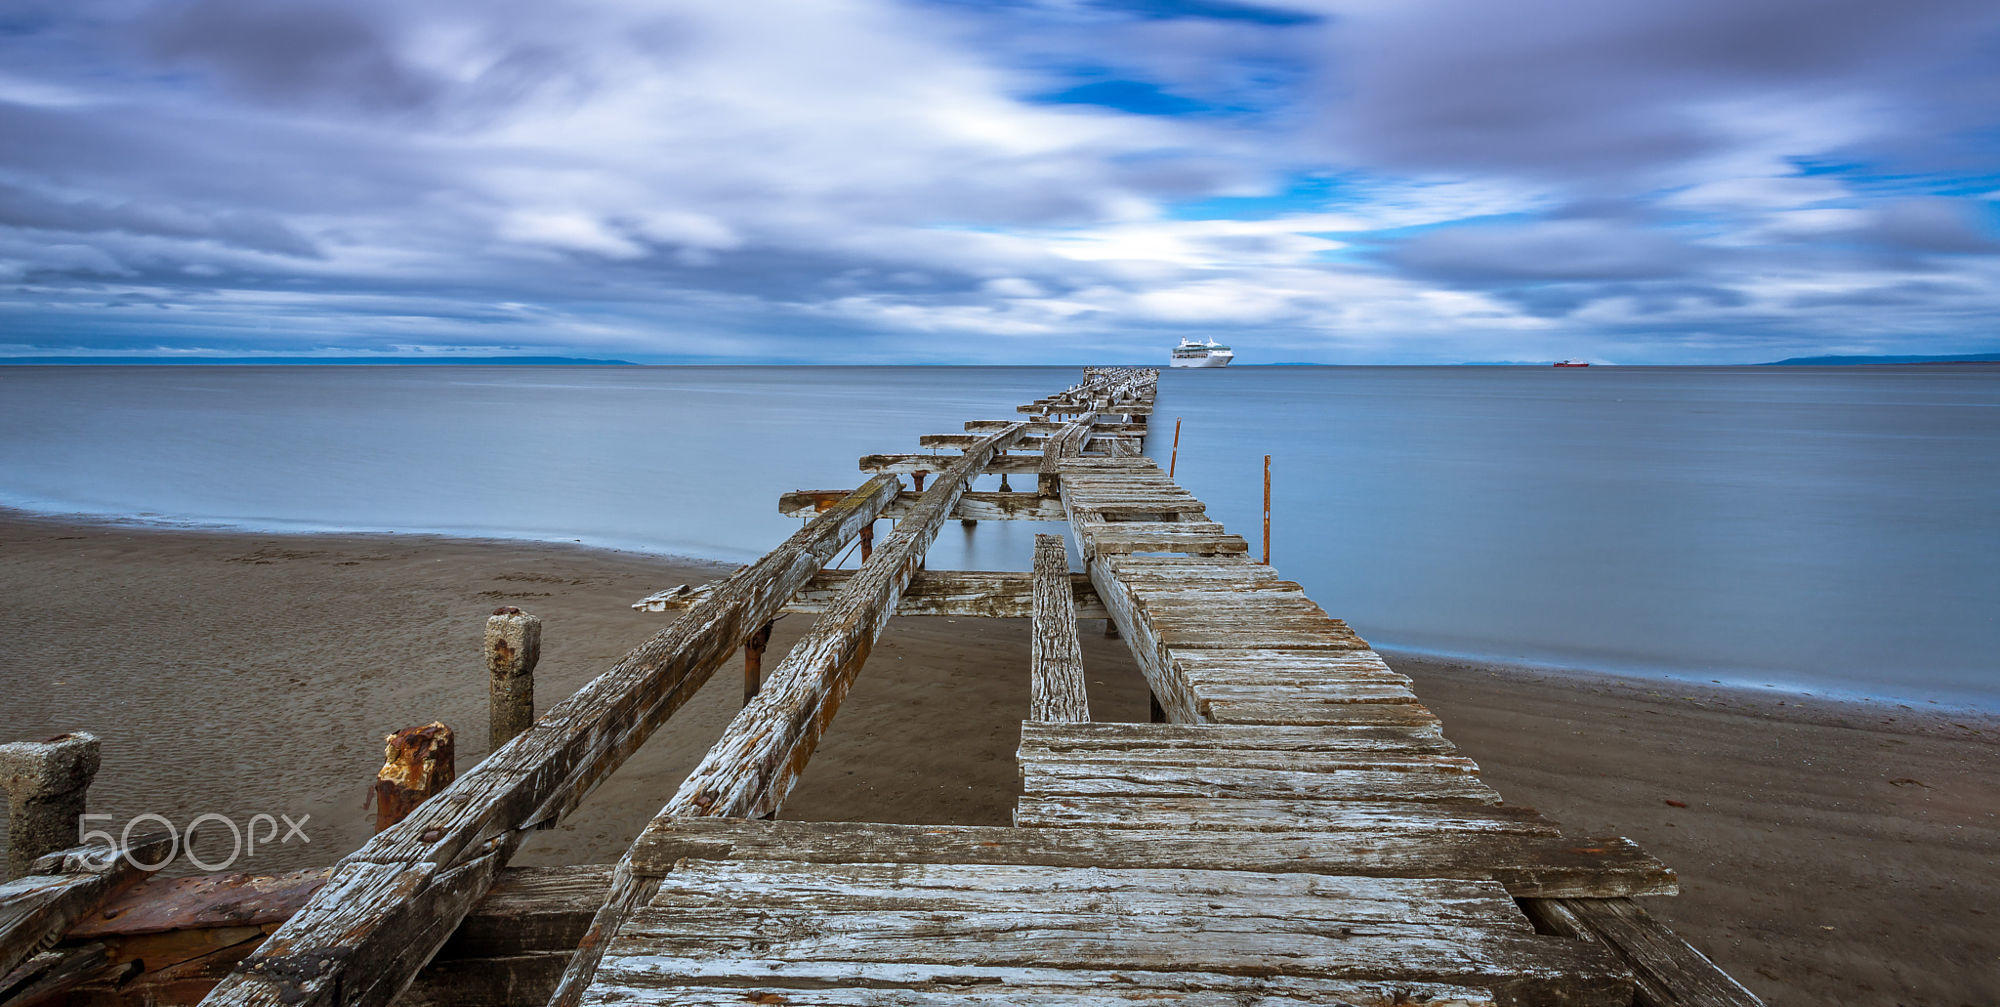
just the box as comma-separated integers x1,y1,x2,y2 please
0,0,2000,364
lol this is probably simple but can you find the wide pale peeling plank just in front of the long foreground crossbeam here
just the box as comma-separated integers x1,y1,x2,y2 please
648,861,1534,933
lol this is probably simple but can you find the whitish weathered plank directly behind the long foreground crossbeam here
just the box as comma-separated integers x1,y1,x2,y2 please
1014,797,1560,839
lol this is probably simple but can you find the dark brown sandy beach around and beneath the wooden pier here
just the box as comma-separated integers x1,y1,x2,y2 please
0,513,2000,1007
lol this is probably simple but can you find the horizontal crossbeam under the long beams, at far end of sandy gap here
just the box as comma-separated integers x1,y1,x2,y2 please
632,569,1108,619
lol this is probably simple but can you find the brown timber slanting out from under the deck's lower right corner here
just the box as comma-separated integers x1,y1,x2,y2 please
1522,899,1764,1007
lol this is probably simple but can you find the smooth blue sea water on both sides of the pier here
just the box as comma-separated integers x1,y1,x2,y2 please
0,366,2000,709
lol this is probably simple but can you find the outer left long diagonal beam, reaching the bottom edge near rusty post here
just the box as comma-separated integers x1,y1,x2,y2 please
202,478,898,1007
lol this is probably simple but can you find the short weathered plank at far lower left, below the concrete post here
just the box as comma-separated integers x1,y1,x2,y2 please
0,833,174,977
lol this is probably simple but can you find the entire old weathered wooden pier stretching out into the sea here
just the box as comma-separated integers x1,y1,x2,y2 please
0,368,1758,1007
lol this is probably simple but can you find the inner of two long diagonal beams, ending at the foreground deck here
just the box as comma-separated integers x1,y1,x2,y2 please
548,424,1024,1007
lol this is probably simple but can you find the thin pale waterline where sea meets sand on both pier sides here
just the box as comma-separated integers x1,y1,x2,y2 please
11,504,2000,725
